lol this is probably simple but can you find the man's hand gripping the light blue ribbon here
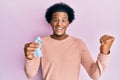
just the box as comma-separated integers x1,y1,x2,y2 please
24,42,39,60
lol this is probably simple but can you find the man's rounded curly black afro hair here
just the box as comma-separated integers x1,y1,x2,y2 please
45,2,75,23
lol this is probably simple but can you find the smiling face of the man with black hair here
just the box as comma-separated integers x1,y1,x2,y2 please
50,12,69,36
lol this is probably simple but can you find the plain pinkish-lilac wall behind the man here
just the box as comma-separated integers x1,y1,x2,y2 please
0,0,120,80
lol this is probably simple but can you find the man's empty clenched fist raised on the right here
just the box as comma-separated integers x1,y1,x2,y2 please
100,35,114,54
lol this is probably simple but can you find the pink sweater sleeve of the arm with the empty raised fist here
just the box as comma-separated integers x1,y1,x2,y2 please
81,41,109,80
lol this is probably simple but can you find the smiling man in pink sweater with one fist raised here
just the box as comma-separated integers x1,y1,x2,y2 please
24,3,114,80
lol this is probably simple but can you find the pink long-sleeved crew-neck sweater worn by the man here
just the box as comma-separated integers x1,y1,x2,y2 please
25,36,109,80
